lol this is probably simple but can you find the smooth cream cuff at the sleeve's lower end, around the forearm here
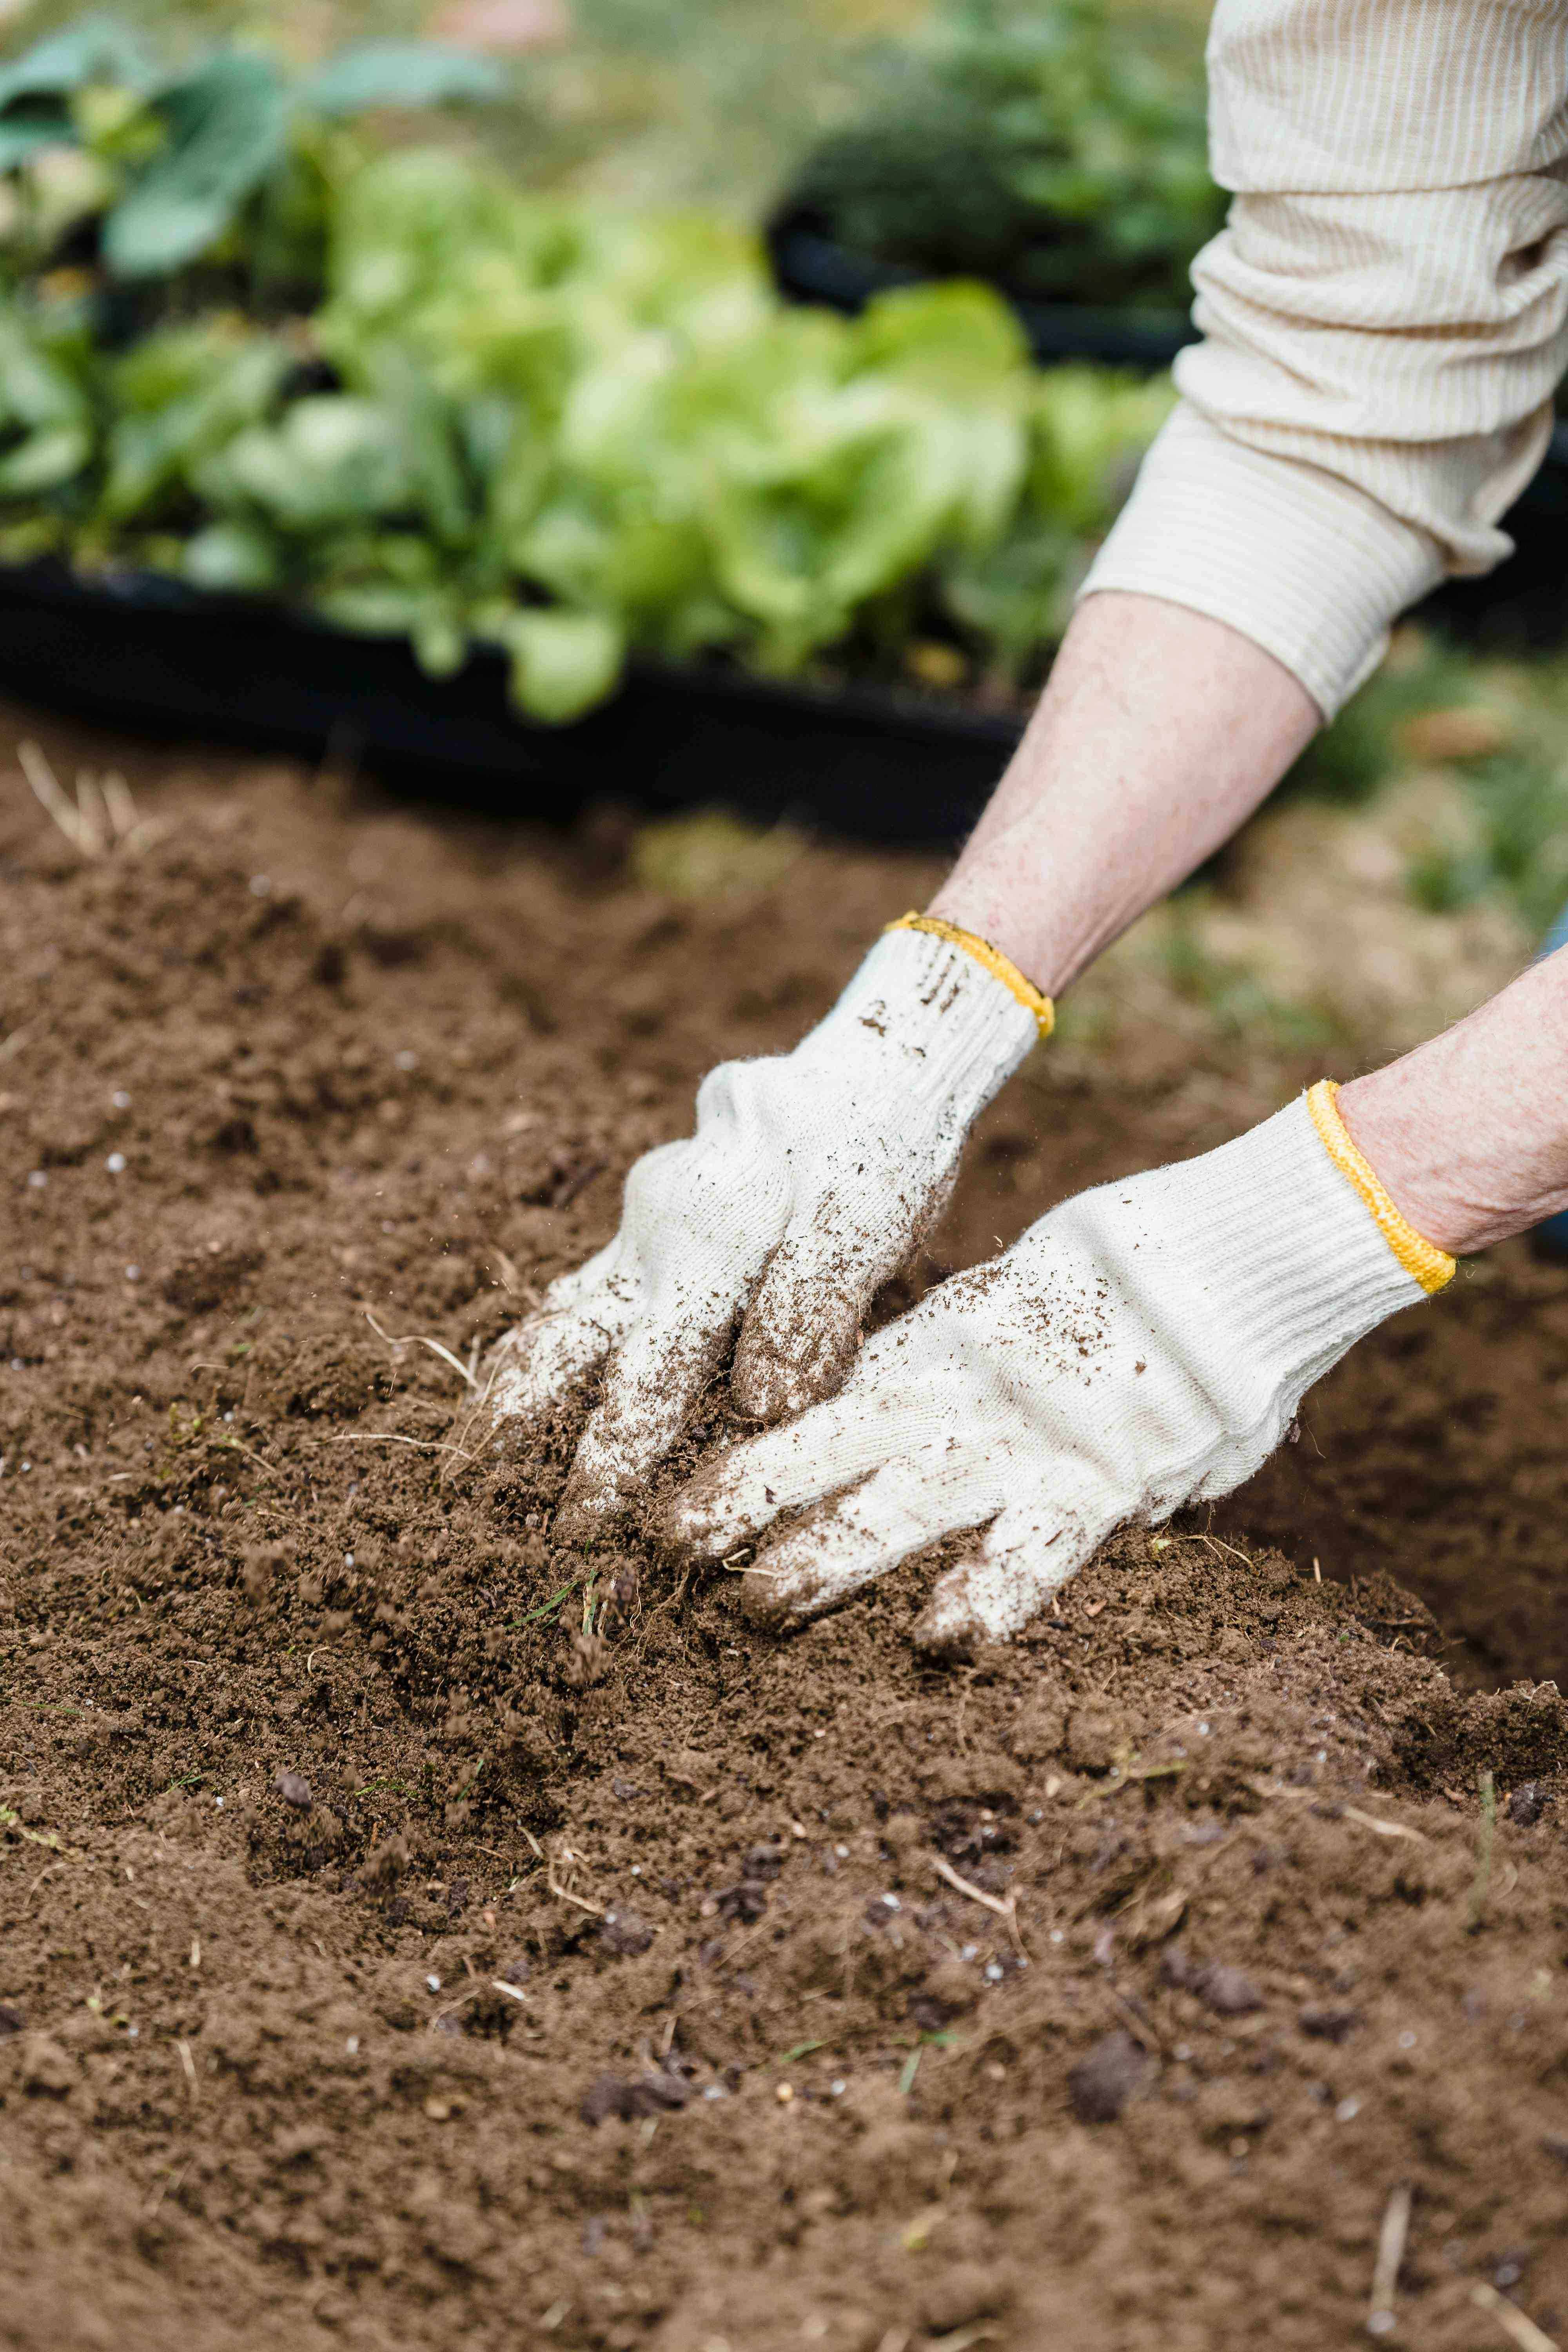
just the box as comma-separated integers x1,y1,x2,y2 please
1079,402,1443,720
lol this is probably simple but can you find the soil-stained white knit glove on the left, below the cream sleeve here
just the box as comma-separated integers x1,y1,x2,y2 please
482,915,1051,1541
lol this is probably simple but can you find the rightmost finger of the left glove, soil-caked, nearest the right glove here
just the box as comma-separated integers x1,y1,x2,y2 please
731,1185,945,1421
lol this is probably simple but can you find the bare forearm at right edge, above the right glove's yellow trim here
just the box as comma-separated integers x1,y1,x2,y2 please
1340,948,1568,1256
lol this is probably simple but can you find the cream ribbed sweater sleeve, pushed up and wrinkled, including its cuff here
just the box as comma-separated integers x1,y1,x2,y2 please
1084,0,1568,717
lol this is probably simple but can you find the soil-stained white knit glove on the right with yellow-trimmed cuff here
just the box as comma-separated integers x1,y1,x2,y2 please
668,1080,1453,1649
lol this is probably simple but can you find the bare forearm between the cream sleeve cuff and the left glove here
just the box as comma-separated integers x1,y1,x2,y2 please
931,593,1321,995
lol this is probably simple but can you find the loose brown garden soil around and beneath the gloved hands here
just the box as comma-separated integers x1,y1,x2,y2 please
0,720,1568,2352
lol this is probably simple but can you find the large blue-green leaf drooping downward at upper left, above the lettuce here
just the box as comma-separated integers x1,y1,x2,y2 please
103,52,287,278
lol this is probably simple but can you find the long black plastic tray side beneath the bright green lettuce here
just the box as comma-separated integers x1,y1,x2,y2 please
0,564,1020,844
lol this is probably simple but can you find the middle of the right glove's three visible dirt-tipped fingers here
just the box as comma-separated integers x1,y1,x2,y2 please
740,1463,969,1625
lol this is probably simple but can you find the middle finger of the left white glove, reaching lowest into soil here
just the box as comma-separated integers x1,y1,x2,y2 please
555,1282,740,1543
